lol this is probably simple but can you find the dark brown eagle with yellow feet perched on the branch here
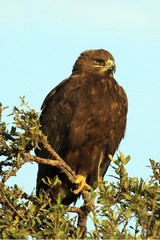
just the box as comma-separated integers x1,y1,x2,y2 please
36,49,128,205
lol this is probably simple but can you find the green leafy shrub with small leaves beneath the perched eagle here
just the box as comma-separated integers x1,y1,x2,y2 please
0,98,160,239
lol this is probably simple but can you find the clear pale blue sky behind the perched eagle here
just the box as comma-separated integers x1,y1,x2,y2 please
0,0,160,192
